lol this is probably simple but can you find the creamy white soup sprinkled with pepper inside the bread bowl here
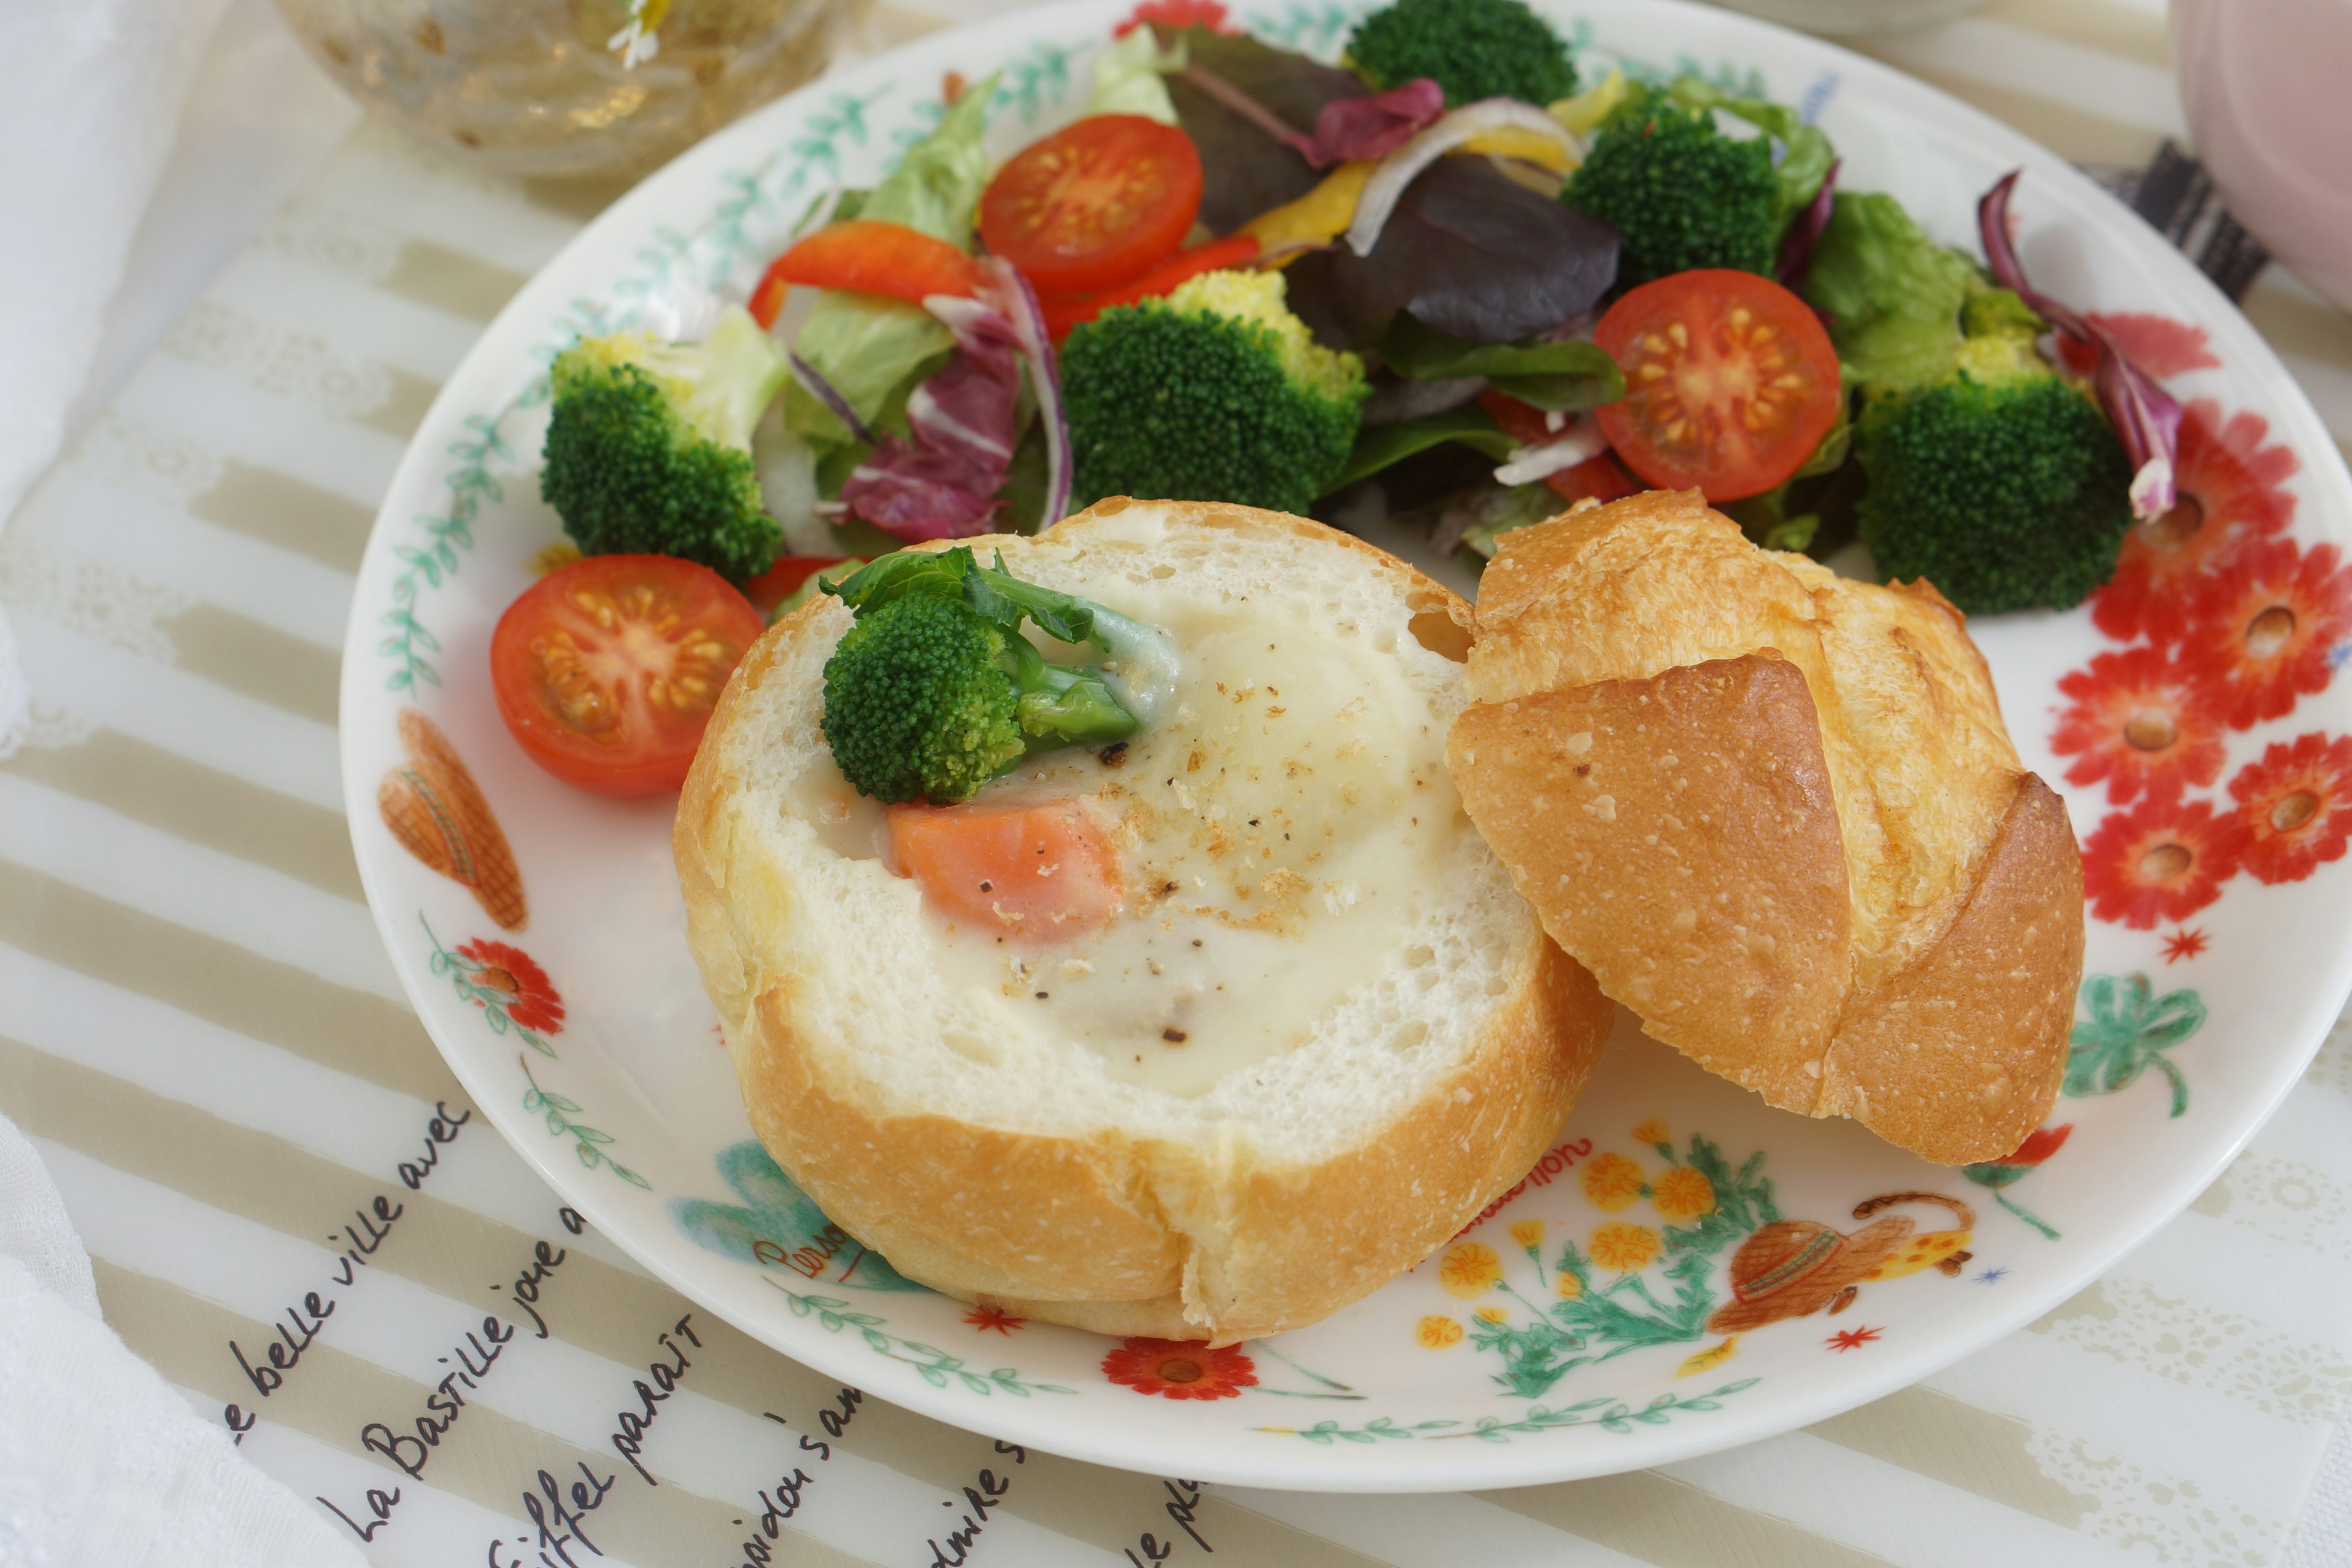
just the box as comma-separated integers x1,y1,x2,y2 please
795,583,1463,1096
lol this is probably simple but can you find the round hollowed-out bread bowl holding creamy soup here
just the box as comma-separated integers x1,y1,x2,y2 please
675,499,1613,1344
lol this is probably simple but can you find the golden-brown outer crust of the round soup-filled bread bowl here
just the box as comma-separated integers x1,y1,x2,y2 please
675,499,1613,1344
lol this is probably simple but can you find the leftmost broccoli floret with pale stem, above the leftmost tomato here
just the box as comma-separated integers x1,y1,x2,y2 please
538,308,788,581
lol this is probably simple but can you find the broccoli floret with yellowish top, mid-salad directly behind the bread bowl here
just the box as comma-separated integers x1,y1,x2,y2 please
1061,273,1366,513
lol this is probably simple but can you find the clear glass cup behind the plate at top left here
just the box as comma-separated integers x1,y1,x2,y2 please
277,0,865,179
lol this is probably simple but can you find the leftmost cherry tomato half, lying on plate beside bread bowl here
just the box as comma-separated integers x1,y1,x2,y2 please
489,555,760,794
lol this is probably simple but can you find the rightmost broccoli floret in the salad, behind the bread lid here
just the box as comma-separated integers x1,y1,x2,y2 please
1856,371,2131,616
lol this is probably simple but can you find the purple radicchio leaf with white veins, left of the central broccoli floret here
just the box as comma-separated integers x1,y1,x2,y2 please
840,296,1021,543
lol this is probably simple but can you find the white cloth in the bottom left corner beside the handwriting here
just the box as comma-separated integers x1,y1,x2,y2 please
0,1117,364,1568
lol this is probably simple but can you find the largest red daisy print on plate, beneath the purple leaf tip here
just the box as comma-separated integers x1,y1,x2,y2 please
2091,398,2301,644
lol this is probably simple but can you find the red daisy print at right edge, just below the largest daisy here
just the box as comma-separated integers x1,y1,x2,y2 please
2180,538,2352,729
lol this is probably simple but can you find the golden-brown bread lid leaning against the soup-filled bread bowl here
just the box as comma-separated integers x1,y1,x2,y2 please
1449,491,2084,1164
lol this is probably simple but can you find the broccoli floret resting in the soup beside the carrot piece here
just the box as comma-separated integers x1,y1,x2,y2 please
823,548,1176,806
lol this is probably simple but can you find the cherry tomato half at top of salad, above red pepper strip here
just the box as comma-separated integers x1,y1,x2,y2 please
981,115,1199,294
